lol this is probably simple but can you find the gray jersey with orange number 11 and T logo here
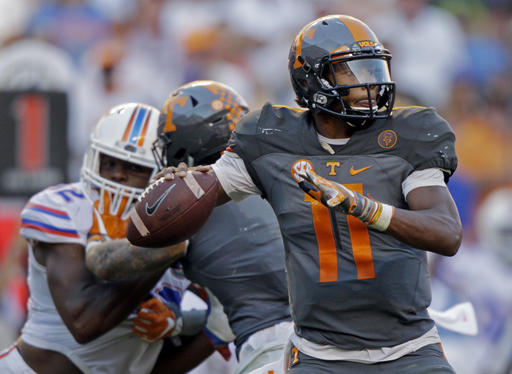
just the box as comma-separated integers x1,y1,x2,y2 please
228,105,457,350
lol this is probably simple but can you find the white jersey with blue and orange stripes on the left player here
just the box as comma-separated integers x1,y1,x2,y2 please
20,183,190,374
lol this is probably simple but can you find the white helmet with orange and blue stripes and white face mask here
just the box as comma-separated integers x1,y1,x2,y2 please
80,103,160,219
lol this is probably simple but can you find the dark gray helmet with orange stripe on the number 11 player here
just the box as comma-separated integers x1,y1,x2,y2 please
288,15,395,127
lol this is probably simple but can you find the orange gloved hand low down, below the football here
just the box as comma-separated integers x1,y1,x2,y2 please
133,297,183,343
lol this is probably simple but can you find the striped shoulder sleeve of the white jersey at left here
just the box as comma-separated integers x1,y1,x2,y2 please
20,183,92,246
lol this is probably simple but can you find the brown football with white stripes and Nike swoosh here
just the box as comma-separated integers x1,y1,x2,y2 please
126,172,217,248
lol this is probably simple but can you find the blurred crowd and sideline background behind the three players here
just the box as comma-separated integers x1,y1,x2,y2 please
0,0,512,373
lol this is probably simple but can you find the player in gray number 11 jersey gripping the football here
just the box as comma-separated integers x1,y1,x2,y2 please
151,15,462,374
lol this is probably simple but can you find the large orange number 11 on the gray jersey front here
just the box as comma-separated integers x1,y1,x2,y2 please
304,183,375,282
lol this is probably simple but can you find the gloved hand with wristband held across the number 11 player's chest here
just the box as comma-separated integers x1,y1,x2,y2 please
298,170,394,231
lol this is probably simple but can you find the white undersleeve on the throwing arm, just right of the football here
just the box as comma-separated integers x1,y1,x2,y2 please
212,152,261,201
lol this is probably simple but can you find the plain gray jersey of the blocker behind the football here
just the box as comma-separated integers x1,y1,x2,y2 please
183,196,291,349
